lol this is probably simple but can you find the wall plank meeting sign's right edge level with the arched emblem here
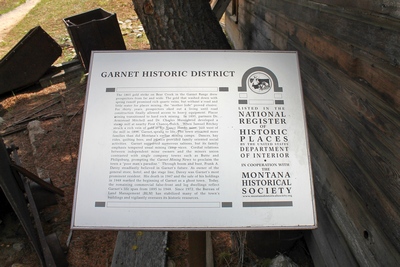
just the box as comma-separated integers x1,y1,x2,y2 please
303,69,400,203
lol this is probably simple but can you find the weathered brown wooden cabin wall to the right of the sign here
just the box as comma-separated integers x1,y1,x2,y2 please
225,0,400,266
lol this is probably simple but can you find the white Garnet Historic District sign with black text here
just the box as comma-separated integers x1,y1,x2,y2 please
72,51,316,230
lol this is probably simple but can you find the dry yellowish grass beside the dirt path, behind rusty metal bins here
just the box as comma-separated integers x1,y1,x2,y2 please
0,0,149,62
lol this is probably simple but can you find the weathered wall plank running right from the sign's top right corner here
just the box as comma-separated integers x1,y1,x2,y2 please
299,52,400,154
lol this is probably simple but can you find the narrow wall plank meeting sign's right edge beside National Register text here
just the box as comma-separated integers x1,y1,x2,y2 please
306,99,400,254
